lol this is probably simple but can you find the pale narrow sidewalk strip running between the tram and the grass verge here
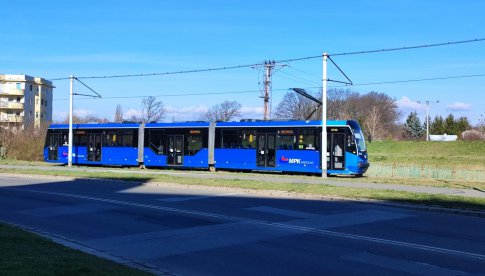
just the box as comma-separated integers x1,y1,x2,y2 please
0,165,485,198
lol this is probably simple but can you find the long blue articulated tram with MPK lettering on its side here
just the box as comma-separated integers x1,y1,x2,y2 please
44,120,369,176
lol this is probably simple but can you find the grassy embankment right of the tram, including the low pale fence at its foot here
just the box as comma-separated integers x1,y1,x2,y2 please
367,141,485,190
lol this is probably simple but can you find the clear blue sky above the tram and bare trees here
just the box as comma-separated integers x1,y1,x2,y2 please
0,0,485,124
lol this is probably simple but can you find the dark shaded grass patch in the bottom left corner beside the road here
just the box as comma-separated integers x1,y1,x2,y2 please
0,224,151,275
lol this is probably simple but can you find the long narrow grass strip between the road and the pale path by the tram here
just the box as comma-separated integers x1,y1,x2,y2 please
2,169,485,210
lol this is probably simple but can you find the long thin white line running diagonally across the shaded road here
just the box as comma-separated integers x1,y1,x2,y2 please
4,188,485,260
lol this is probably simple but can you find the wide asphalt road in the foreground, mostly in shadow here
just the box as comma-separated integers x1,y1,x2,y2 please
0,175,485,275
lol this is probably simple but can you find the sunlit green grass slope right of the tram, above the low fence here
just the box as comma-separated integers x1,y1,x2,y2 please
368,141,485,170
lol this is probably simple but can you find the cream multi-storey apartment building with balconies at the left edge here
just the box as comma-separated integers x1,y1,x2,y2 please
0,75,55,129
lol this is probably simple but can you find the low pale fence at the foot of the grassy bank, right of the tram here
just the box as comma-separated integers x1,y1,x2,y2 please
366,164,485,182
